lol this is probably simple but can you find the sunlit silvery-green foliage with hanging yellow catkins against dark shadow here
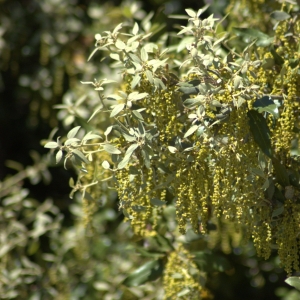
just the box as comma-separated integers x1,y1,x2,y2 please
0,0,300,299
